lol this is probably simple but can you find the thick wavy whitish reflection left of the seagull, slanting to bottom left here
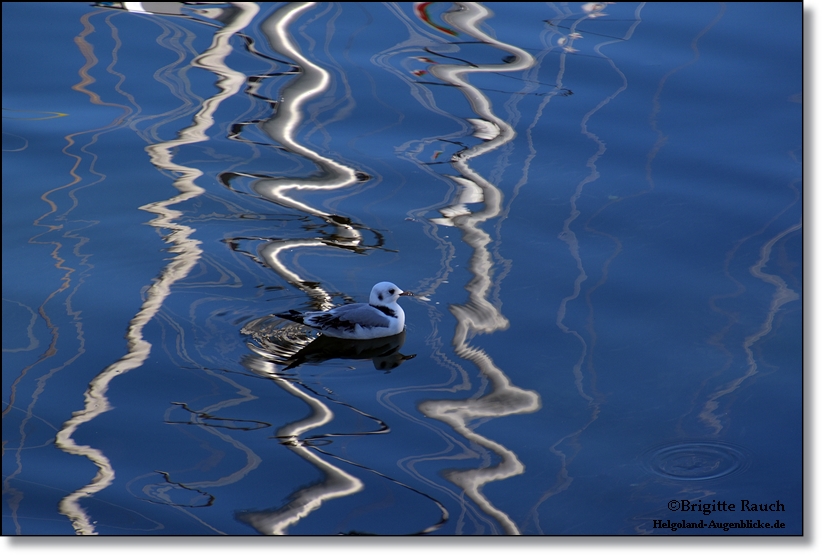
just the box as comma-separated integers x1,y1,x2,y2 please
55,3,258,535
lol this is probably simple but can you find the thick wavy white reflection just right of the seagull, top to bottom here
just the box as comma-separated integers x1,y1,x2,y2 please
410,3,541,534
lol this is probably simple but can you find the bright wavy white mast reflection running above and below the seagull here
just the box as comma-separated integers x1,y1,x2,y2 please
232,3,374,535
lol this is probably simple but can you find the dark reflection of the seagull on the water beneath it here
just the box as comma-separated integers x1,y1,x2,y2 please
281,330,417,372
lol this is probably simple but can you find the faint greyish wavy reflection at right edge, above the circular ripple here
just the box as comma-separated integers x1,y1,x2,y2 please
699,222,802,434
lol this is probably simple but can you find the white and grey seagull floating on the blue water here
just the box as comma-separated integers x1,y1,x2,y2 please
275,281,414,339
